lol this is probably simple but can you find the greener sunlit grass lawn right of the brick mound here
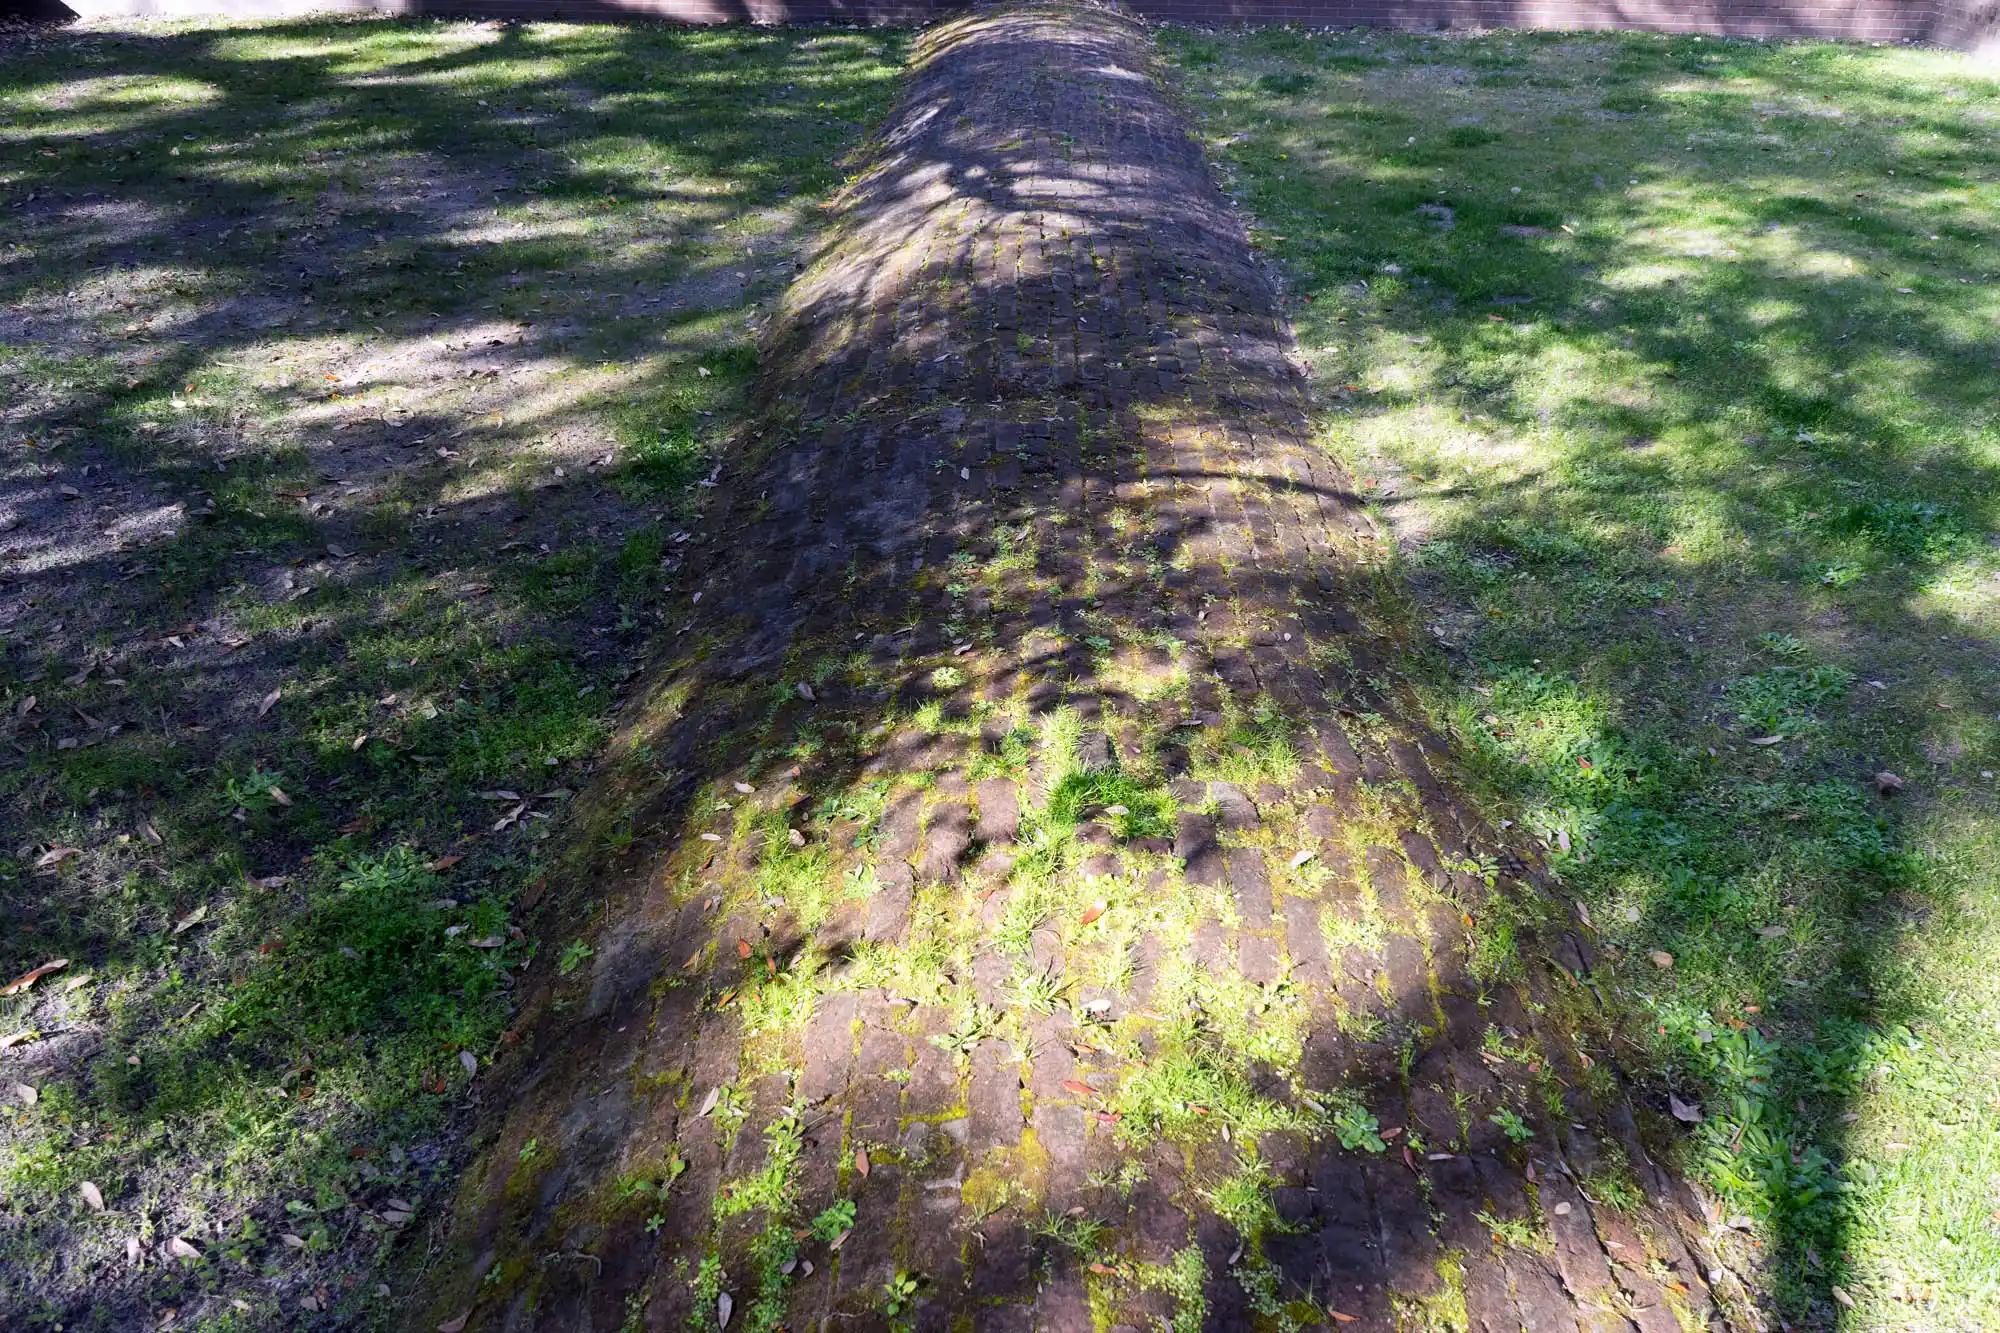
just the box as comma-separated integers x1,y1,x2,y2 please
1164,30,2000,1329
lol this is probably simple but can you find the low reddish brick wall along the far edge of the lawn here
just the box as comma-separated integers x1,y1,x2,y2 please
54,0,2000,62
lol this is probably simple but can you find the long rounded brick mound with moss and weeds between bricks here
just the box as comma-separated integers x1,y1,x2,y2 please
420,6,1732,1333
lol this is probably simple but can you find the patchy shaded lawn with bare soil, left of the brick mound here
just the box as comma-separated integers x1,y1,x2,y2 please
0,22,902,1329
